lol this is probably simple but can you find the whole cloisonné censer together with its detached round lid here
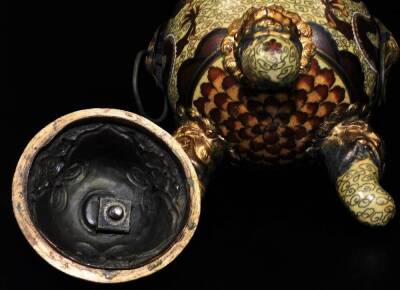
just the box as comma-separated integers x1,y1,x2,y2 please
13,0,399,283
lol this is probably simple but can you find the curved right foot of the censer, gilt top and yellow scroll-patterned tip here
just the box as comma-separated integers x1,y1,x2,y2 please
321,120,396,226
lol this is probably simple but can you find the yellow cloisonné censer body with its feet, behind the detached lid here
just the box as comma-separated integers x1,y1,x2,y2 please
143,0,400,226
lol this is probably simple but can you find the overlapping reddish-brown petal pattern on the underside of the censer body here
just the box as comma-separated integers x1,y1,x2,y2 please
194,58,349,165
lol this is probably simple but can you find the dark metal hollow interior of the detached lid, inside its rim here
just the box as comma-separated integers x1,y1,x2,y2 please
27,119,190,269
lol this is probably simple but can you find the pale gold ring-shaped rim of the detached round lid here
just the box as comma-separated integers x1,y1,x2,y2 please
12,109,201,283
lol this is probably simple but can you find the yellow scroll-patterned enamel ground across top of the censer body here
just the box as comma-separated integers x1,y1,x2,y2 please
167,0,376,108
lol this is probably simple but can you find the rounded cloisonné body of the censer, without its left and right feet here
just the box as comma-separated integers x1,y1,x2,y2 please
147,0,397,165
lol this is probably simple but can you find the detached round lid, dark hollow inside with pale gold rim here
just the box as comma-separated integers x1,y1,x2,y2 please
13,109,200,283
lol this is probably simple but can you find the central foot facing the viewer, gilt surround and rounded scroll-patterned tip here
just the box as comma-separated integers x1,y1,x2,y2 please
221,5,315,90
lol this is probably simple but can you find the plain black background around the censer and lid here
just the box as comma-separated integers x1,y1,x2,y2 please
4,0,400,290
